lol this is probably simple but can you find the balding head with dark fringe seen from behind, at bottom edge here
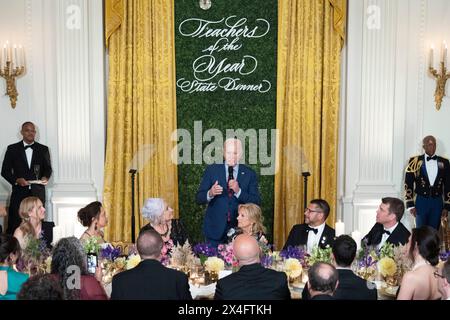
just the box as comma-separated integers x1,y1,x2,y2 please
308,262,339,300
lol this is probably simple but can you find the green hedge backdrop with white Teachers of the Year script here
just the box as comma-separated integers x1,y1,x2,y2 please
175,0,277,243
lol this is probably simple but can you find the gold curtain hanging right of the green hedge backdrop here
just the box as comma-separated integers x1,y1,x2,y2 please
274,0,346,249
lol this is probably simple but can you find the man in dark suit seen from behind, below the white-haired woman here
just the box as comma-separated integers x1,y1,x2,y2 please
111,229,192,300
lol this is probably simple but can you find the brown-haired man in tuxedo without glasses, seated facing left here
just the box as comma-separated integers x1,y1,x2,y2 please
362,197,411,249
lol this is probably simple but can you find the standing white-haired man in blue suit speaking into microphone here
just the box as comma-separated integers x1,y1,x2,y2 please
196,139,261,246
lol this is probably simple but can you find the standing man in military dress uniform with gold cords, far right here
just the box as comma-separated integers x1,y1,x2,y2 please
405,136,450,230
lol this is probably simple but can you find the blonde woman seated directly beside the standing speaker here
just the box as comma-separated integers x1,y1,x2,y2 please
228,203,268,244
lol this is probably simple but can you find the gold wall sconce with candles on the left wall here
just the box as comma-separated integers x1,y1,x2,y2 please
0,41,25,108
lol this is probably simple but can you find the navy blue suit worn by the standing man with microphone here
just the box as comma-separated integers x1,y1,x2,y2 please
196,164,261,241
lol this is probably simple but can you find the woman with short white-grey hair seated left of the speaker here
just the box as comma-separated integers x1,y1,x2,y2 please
141,198,188,245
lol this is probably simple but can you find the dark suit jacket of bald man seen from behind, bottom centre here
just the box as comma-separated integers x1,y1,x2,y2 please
214,263,291,300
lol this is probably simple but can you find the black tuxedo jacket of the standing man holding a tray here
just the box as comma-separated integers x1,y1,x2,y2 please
2,141,52,199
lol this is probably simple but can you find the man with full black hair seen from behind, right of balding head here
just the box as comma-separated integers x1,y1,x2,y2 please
302,235,377,300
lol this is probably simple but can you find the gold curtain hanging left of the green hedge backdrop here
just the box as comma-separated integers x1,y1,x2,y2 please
104,0,178,241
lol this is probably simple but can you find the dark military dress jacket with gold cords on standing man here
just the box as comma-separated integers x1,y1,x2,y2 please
405,154,450,210
